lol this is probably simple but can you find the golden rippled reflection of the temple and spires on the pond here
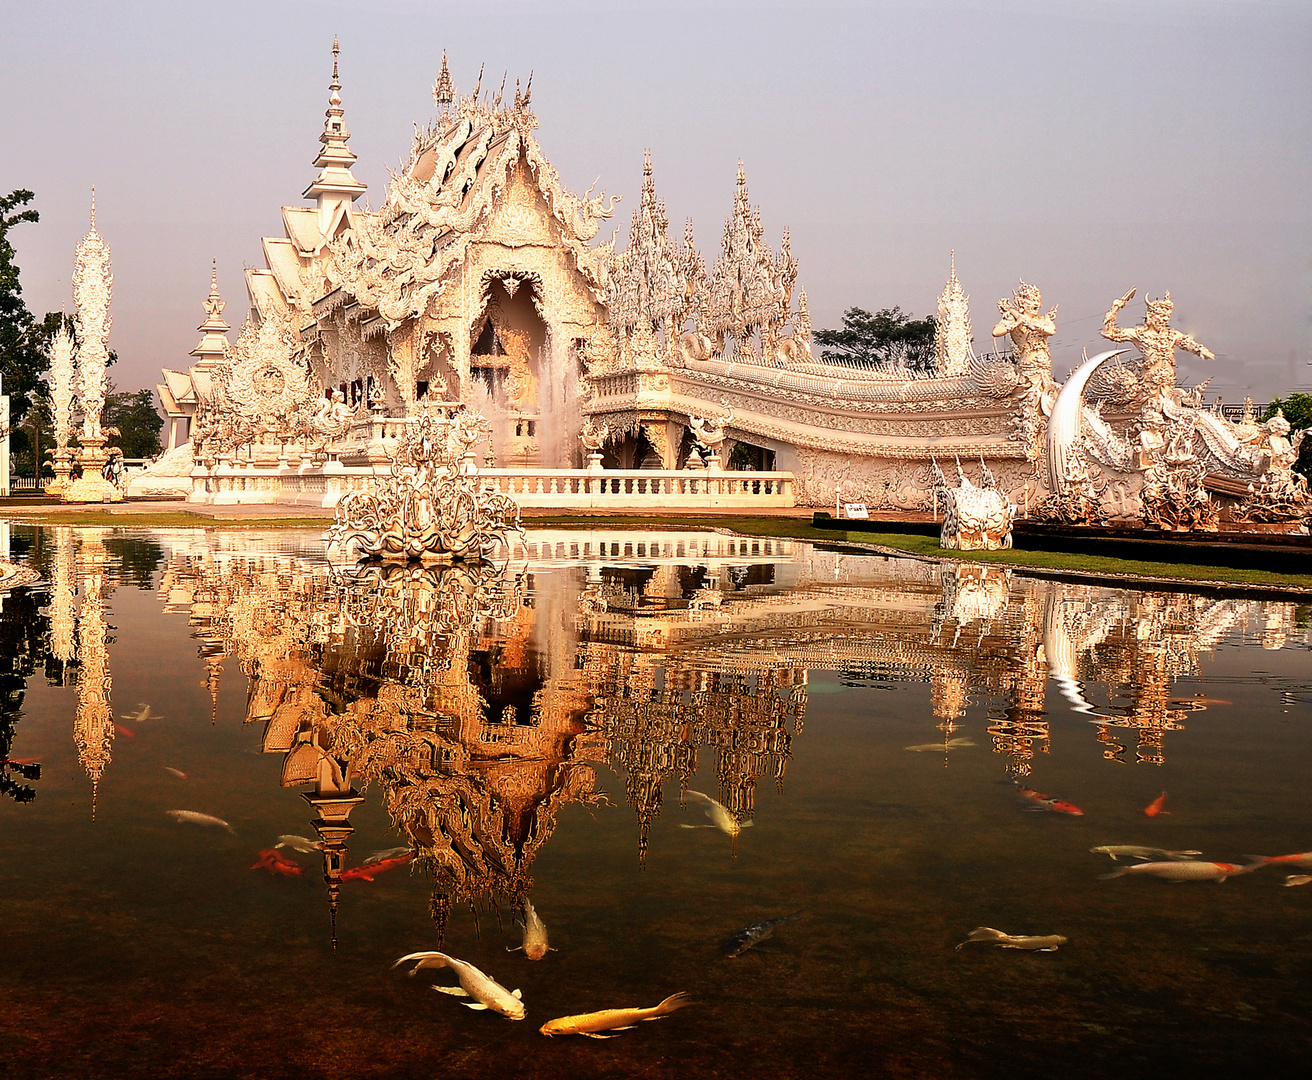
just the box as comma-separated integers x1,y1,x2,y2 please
20,529,1305,933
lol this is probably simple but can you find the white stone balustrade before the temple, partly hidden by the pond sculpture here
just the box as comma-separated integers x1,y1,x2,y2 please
189,461,794,509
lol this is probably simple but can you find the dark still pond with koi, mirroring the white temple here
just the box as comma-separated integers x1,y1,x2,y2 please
0,526,1312,1077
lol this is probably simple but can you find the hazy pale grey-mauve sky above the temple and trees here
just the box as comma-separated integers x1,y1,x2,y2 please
0,0,1312,400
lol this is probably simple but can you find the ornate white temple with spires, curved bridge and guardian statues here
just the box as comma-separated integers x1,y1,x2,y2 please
134,42,1309,529
